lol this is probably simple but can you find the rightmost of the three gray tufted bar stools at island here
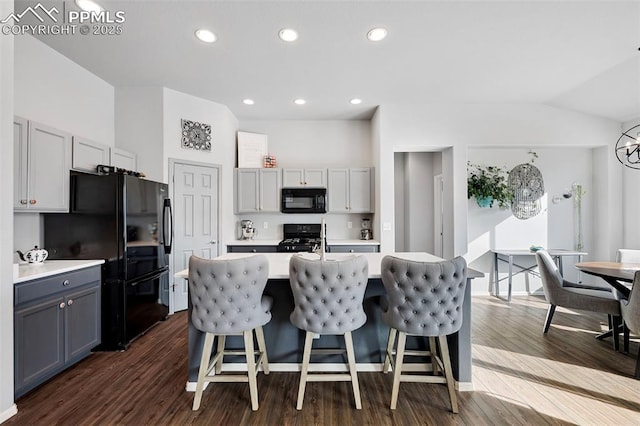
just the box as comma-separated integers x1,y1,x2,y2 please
381,256,467,413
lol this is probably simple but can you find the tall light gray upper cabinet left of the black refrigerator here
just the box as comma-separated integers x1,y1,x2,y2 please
13,117,71,212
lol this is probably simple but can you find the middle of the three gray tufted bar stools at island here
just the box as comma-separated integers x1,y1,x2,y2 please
289,255,369,410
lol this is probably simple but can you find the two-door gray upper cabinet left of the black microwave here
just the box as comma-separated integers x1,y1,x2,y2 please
235,169,282,213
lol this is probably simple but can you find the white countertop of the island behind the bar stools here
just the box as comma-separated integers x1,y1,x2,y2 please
175,251,484,279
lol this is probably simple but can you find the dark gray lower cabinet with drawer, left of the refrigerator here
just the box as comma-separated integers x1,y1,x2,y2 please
14,266,101,398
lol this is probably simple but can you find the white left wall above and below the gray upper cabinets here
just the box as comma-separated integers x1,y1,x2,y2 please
13,35,115,253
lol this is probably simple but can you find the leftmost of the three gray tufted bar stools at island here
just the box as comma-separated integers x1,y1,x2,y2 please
189,255,273,411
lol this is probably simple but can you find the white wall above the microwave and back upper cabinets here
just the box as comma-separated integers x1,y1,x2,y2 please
240,120,374,167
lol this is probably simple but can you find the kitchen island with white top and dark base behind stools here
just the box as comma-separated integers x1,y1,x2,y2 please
175,252,482,391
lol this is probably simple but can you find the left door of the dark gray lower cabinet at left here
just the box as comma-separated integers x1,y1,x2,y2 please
14,297,66,395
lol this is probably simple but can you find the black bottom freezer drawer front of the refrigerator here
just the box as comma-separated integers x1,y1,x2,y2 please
125,269,169,344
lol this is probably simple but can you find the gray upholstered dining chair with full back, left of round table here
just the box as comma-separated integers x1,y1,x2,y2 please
536,250,621,350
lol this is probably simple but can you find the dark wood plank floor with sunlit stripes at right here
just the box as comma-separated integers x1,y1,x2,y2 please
6,297,640,425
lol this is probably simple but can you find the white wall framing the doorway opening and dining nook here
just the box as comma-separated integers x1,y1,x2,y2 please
374,104,622,262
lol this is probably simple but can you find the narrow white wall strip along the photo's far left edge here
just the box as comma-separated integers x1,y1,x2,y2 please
0,2,17,423
